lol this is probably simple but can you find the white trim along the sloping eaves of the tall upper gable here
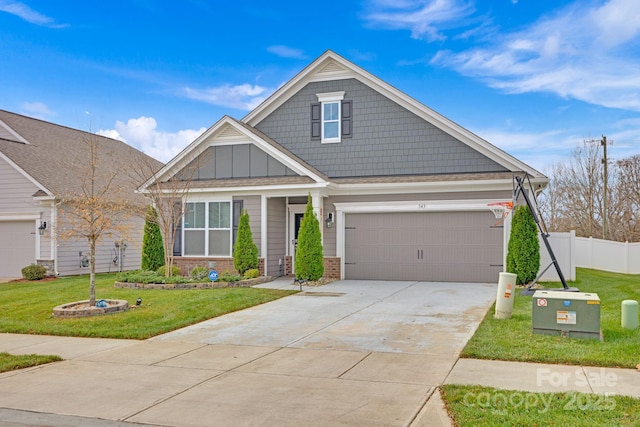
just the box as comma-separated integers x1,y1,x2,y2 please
242,50,545,179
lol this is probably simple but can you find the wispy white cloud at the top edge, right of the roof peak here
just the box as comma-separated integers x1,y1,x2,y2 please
365,0,474,41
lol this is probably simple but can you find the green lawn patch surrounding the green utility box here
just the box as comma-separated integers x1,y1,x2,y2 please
461,268,640,368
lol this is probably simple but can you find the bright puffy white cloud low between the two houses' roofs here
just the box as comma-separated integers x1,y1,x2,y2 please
97,117,206,163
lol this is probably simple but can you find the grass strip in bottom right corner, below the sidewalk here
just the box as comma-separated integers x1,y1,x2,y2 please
440,385,640,427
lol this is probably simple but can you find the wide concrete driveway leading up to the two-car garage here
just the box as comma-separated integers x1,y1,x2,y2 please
0,280,496,426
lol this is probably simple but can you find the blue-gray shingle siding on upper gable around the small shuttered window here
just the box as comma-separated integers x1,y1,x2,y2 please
255,79,506,178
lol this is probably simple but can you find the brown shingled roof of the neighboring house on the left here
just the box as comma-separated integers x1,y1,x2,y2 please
0,110,162,204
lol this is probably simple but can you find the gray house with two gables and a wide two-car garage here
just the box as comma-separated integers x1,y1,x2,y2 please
141,51,548,282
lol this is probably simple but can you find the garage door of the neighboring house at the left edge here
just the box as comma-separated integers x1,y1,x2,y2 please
0,221,36,278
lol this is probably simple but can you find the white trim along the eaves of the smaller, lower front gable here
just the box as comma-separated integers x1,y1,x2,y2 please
140,116,328,191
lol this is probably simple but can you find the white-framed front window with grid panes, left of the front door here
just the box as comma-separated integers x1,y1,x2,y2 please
184,202,232,256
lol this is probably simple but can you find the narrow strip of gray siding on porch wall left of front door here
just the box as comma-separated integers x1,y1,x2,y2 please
267,197,287,277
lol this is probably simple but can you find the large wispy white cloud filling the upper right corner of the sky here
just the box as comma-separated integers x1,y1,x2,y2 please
432,0,640,111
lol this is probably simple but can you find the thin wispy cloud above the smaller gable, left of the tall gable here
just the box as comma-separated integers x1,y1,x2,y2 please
183,83,268,110
